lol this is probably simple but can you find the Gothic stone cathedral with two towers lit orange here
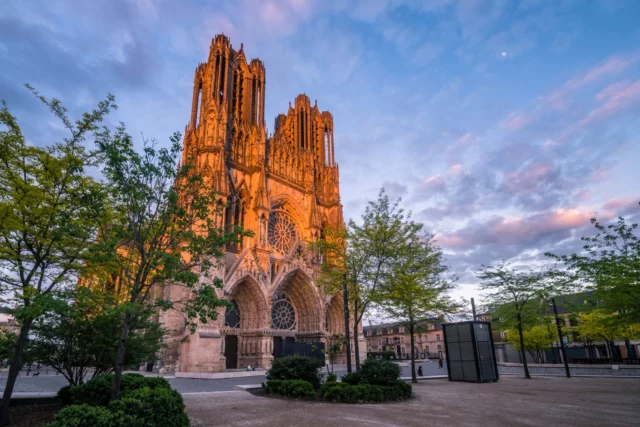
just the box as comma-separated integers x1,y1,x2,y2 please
157,35,366,372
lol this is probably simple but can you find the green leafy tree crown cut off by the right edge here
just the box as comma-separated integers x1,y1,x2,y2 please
546,217,640,325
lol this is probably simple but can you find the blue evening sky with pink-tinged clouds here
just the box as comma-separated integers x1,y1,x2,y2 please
0,0,640,310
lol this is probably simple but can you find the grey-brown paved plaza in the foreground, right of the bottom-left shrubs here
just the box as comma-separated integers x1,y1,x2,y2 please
184,377,640,427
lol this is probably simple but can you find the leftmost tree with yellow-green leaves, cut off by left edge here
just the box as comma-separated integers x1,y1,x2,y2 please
0,86,116,425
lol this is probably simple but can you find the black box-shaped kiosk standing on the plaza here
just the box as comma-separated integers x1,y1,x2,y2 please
442,321,499,383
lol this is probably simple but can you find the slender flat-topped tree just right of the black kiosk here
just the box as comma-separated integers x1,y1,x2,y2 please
477,262,559,379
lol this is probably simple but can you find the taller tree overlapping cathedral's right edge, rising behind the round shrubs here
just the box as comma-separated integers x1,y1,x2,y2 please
315,188,422,369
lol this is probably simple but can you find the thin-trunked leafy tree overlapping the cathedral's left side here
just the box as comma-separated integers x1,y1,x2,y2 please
94,125,251,399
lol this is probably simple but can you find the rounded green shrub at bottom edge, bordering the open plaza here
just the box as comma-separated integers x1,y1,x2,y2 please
108,387,189,427
